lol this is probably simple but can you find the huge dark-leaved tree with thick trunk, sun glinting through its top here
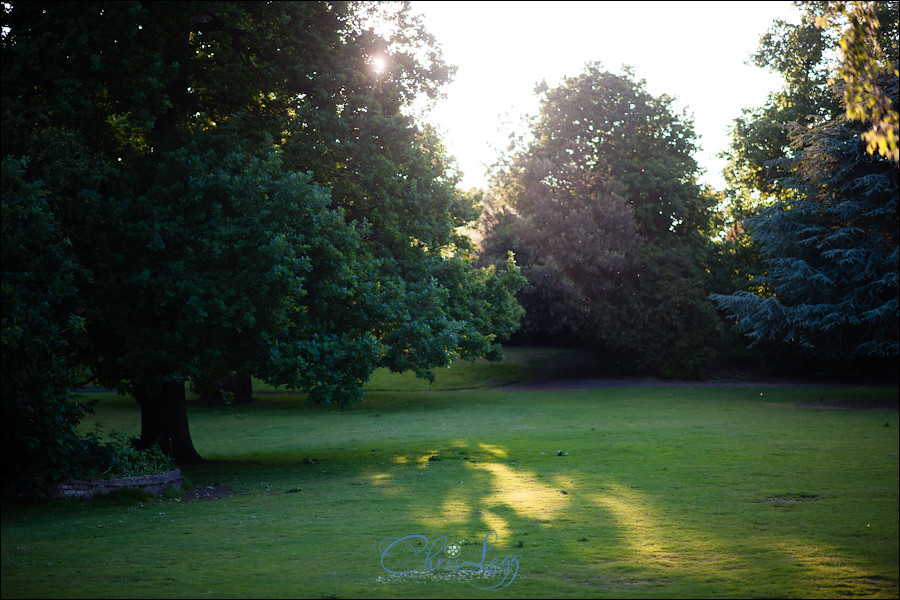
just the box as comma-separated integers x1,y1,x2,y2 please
2,2,517,462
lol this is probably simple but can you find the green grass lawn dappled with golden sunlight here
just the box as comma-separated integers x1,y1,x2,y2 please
2,351,900,598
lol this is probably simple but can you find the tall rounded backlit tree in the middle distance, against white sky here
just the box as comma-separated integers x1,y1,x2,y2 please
485,64,716,376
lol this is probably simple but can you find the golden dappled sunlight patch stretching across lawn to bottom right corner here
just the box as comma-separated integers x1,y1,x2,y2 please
368,444,896,596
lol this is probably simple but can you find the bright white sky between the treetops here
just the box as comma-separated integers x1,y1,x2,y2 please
412,1,799,189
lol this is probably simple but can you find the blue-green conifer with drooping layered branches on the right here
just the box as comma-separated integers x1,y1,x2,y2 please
714,78,900,360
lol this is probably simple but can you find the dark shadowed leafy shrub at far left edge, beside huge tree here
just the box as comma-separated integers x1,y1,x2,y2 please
0,157,89,485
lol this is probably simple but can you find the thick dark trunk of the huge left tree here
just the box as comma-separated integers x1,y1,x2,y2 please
135,381,203,465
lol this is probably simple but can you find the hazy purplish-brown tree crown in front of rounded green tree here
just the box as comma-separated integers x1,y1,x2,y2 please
482,157,639,343
